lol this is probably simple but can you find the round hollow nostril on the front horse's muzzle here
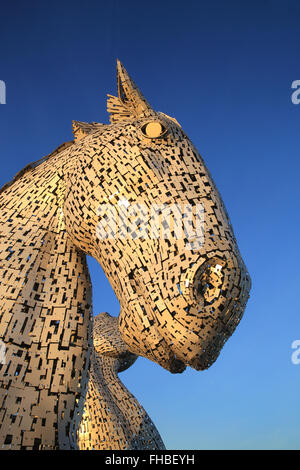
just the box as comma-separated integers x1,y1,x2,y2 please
191,258,226,305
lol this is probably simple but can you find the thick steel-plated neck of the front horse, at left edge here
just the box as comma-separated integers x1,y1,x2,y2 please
0,152,91,449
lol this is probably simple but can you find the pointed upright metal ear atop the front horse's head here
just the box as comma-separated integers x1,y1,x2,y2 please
107,60,156,123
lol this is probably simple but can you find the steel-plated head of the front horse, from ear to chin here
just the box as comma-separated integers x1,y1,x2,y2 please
64,62,249,372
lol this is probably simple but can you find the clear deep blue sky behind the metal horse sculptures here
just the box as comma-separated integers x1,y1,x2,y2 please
0,0,300,449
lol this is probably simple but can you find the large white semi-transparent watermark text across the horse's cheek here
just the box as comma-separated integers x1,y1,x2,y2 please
96,202,204,250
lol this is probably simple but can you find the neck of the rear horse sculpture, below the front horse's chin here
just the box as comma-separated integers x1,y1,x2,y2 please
78,351,165,450
